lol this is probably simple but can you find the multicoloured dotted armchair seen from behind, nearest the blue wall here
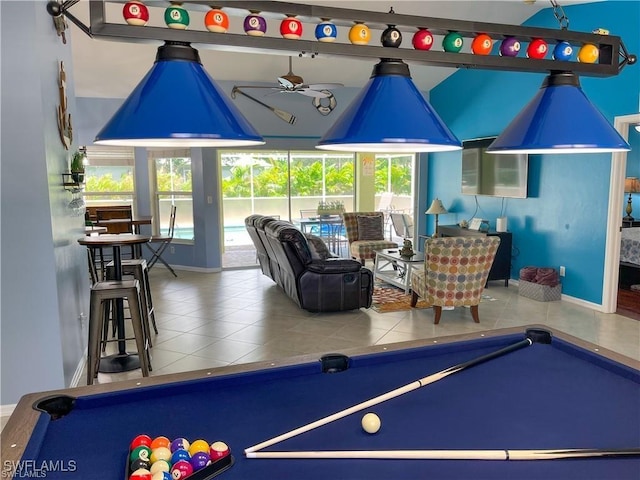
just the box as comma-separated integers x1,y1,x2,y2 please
411,236,500,324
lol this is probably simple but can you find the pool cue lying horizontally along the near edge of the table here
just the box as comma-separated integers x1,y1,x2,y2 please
247,448,640,460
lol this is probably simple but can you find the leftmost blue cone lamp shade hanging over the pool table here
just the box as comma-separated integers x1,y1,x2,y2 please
95,42,264,147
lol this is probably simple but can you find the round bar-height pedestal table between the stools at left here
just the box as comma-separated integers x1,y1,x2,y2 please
78,234,151,373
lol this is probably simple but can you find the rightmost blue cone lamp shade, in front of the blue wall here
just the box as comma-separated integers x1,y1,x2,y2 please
487,72,630,154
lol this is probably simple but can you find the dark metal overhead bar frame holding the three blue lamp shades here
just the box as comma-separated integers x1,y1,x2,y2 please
47,0,637,77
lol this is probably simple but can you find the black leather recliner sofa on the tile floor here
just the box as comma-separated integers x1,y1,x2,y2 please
245,215,373,312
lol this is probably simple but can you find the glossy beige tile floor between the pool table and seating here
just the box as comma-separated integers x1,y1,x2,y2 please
91,266,640,383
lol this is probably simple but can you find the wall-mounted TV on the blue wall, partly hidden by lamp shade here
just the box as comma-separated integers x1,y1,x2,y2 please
462,137,529,198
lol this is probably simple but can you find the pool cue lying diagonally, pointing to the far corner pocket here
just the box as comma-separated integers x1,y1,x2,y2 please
244,337,533,454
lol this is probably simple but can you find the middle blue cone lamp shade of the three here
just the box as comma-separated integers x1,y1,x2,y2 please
316,59,462,152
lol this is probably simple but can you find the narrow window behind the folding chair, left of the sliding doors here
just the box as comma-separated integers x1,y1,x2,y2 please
148,149,194,243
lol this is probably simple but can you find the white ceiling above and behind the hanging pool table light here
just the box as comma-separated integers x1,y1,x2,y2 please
69,0,585,98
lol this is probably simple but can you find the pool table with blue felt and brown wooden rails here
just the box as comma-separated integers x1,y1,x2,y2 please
1,326,640,480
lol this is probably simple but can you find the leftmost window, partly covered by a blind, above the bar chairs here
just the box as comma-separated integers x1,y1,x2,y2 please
84,146,135,208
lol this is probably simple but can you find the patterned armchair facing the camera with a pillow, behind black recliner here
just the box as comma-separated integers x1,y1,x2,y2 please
342,212,398,265
